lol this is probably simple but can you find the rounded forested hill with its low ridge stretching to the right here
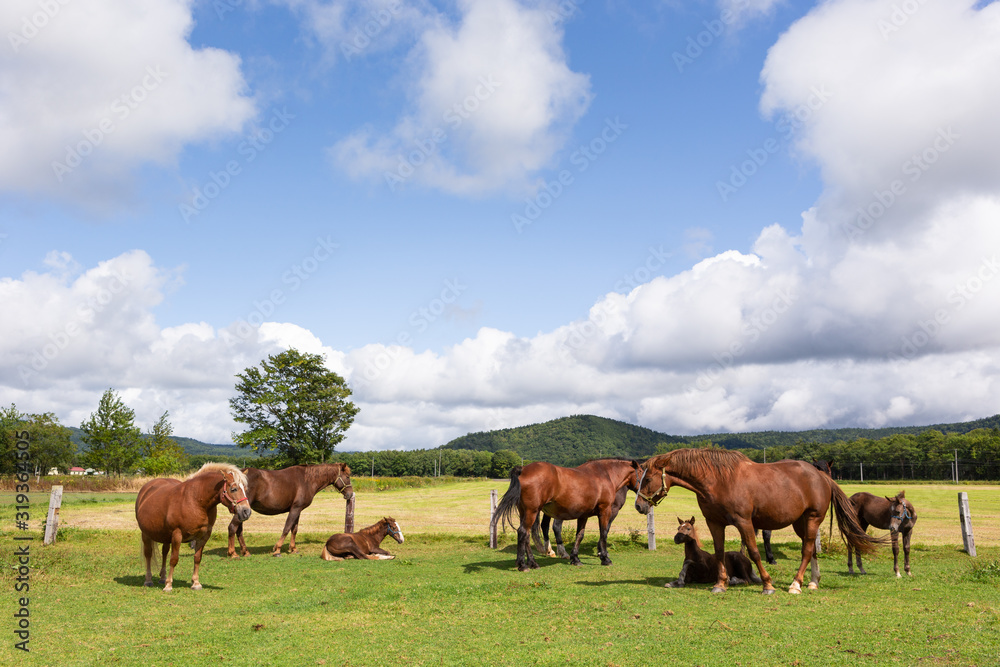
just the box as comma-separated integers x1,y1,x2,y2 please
443,415,1000,466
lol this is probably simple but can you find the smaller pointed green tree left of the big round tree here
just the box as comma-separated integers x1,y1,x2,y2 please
80,389,142,475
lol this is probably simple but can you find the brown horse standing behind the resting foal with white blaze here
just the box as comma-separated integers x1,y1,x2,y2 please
227,463,354,558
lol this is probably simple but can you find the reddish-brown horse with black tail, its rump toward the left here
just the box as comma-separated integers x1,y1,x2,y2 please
490,458,639,572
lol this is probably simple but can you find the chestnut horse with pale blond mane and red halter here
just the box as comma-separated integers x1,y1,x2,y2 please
135,463,251,591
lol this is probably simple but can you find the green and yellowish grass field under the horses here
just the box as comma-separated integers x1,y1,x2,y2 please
0,482,1000,665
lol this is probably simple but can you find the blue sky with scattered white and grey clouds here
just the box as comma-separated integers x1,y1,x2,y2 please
0,0,1000,449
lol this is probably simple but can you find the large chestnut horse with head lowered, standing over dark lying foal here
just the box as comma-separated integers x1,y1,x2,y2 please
635,449,885,594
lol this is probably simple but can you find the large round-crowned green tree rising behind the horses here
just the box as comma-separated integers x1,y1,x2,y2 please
229,348,358,464
